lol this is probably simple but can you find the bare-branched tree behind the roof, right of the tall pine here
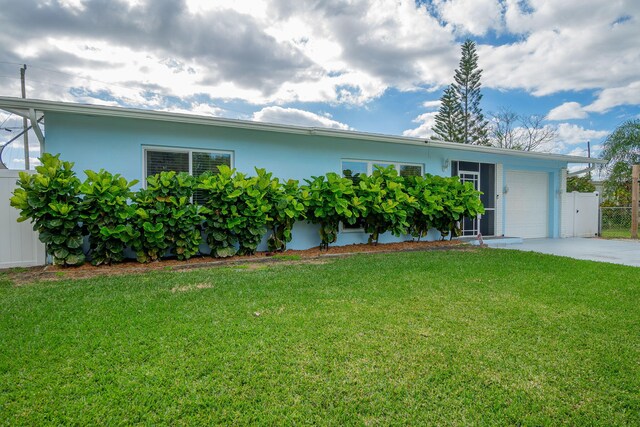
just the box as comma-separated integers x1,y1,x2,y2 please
489,108,558,151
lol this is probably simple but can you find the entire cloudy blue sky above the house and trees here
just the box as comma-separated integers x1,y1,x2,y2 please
0,0,640,167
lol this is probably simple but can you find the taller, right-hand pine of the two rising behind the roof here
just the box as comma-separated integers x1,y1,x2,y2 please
452,40,489,145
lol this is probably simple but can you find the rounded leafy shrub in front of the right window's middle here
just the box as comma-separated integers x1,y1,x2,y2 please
353,166,415,244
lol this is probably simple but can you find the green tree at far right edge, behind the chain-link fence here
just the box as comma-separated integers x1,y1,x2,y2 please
601,119,640,206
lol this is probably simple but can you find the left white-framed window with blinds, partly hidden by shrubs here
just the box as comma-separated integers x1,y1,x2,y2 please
144,147,233,203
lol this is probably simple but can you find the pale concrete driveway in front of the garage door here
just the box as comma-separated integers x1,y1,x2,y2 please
505,237,640,267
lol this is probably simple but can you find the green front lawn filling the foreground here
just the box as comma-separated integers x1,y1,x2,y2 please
0,250,640,425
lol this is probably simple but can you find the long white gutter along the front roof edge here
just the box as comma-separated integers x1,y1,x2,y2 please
0,97,606,163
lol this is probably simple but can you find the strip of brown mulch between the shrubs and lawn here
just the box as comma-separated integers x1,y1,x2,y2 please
2,240,472,285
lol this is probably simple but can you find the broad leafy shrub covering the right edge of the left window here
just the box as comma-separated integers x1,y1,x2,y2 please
198,165,271,257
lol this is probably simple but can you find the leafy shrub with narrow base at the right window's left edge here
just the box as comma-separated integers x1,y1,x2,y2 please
300,172,358,249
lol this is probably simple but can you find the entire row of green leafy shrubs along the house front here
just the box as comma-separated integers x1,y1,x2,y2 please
11,154,484,265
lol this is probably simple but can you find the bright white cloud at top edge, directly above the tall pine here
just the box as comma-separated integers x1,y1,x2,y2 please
433,0,502,36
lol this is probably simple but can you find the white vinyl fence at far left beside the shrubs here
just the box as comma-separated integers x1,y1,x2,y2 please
0,169,45,268
